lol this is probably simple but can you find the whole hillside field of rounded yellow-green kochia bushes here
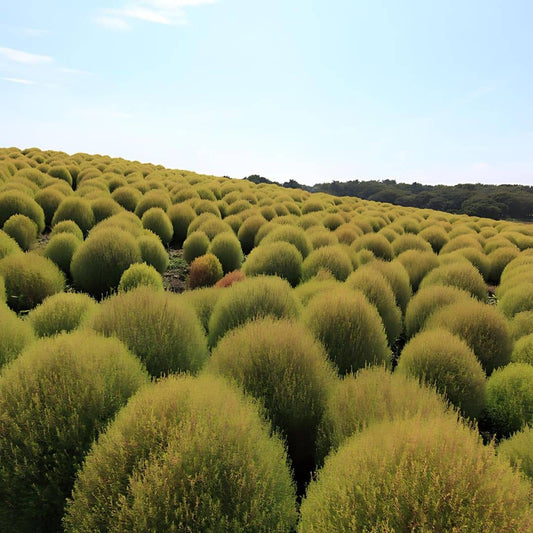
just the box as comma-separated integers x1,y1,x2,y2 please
0,148,533,533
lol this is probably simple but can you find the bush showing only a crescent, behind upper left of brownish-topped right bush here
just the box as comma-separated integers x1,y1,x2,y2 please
405,285,471,338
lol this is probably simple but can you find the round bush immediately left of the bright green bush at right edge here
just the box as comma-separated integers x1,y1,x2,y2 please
397,329,486,419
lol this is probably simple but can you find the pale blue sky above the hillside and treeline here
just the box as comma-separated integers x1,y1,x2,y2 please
0,0,533,185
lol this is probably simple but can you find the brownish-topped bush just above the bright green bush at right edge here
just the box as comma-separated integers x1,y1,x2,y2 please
426,300,513,375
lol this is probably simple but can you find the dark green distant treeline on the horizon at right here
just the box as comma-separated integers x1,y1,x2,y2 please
245,174,533,221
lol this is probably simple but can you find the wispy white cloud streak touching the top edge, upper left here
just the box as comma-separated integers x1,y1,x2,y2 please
96,0,217,30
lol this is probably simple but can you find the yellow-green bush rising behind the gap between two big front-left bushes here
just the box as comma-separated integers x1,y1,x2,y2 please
89,287,207,377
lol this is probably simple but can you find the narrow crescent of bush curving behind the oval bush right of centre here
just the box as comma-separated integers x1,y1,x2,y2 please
346,264,402,346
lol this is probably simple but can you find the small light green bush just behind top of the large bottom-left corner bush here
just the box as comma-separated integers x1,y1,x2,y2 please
27,292,97,337
